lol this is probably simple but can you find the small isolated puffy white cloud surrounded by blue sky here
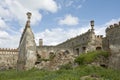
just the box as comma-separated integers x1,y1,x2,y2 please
58,14,79,26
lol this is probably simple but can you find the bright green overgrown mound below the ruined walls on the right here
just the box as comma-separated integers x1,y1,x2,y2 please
75,51,109,65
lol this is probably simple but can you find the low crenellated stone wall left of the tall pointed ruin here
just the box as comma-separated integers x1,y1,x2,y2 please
0,48,18,70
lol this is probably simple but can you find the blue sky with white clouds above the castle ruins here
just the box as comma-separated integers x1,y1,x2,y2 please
0,0,120,48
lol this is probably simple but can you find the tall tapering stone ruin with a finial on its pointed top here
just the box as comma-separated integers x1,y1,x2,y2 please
17,12,37,70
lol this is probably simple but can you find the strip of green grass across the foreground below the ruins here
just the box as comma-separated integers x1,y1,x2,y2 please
0,65,120,80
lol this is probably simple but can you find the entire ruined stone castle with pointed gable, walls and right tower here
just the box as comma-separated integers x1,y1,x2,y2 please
0,12,120,70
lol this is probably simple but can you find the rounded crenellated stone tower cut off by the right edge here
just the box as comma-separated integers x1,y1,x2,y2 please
103,22,120,69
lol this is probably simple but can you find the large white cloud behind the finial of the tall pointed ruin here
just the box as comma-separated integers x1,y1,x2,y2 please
0,0,58,26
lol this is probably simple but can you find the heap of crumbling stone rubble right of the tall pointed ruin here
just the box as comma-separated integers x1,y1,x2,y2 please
36,50,74,70
